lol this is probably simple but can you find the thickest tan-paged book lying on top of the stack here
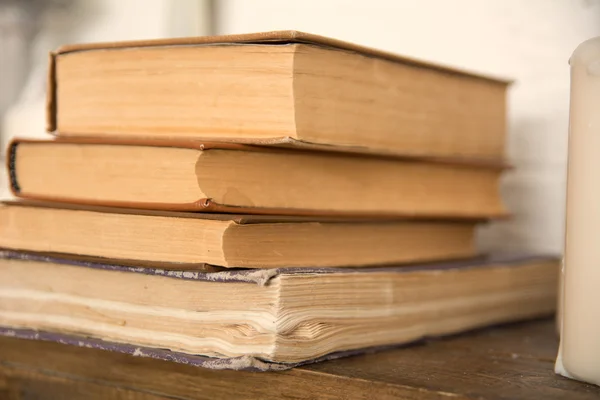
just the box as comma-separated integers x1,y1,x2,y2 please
47,31,509,160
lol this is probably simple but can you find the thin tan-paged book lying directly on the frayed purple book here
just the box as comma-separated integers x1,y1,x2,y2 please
0,202,476,268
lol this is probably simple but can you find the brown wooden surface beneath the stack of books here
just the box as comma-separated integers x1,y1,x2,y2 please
0,320,600,400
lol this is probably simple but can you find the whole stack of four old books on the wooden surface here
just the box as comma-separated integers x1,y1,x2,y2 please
0,31,558,370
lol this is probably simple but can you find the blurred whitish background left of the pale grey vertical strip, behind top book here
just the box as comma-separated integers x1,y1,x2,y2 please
0,0,210,147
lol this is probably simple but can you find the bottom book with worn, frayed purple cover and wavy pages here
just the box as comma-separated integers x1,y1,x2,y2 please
0,251,559,370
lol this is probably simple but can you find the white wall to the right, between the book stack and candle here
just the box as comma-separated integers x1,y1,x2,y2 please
215,0,600,253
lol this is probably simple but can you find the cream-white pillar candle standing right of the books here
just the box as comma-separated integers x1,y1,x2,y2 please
556,37,600,385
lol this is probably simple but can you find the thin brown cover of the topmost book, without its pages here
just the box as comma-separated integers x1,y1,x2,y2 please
47,31,510,159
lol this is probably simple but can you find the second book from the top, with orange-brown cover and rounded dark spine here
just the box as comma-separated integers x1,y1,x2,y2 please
8,138,506,219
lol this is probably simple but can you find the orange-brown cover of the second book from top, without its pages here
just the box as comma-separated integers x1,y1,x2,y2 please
7,137,508,219
